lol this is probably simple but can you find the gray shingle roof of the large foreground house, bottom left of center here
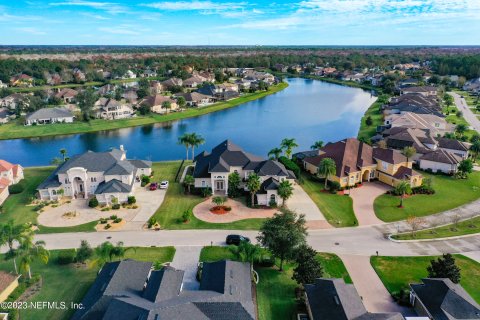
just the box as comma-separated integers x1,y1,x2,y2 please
72,261,255,320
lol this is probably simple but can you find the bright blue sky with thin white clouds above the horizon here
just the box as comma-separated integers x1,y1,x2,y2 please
0,0,480,45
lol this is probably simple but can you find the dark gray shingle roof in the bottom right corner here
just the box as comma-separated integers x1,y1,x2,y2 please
410,279,480,320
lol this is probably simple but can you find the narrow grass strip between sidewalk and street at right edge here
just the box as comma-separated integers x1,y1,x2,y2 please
393,216,480,240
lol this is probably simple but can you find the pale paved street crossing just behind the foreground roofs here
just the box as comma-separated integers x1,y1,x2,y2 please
29,226,480,256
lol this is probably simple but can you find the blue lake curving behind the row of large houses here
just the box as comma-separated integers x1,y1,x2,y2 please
0,78,375,167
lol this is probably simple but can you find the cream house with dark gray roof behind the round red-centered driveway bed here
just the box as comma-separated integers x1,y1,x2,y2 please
193,140,295,205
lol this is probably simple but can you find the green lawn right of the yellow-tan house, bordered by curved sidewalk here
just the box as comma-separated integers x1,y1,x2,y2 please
374,172,480,222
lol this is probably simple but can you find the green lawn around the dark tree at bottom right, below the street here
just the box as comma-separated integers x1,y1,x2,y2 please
370,255,480,303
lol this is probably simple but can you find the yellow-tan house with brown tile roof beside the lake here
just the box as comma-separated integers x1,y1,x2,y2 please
303,138,423,188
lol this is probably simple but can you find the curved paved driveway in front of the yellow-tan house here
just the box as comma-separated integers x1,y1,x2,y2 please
350,182,391,226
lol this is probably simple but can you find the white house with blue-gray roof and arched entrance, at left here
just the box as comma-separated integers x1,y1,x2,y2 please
37,146,152,204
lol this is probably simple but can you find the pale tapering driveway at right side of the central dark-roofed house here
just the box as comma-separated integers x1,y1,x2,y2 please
286,184,331,228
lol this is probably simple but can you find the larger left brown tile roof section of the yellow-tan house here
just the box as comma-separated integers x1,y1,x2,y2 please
304,138,375,177
